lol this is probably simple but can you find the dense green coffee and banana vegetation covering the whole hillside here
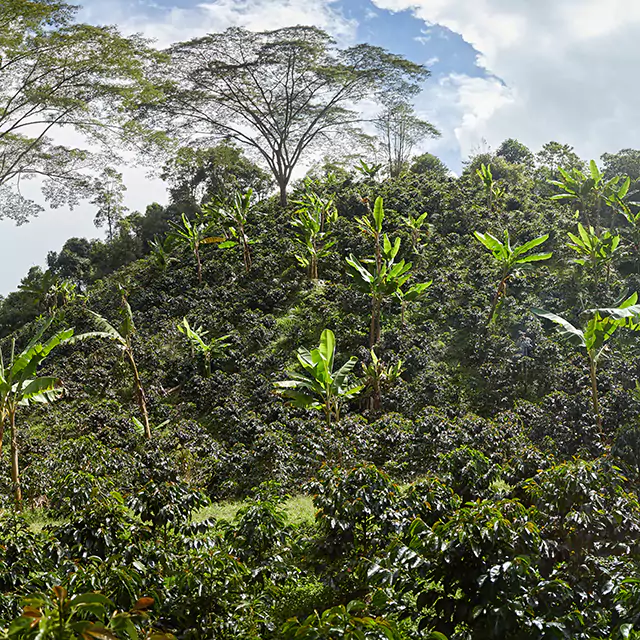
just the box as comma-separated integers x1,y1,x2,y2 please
6,0,640,640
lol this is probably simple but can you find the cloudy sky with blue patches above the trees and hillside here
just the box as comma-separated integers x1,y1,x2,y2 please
0,0,640,294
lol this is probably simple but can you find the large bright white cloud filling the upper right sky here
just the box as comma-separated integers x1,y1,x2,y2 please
373,0,640,158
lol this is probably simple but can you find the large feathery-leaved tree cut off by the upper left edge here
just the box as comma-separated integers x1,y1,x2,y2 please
0,0,151,224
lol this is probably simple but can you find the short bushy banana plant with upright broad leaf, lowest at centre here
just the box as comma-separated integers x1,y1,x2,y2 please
275,329,363,426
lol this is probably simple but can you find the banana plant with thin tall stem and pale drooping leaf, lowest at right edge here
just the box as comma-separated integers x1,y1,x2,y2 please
531,293,640,429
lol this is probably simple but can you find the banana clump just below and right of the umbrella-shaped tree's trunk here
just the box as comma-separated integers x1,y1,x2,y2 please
292,191,338,280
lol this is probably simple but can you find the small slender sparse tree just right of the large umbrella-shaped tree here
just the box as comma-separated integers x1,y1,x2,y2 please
374,101,440,178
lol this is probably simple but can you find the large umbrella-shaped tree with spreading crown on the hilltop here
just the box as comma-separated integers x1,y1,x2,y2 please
138,26,428,205
